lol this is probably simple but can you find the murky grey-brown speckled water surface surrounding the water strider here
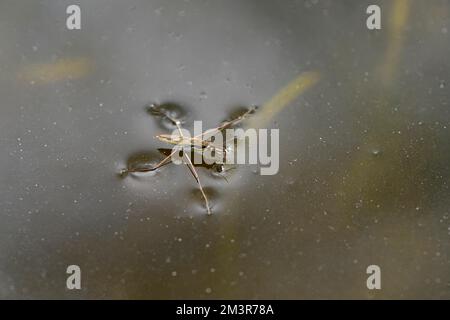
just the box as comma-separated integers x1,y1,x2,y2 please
0,0,450,298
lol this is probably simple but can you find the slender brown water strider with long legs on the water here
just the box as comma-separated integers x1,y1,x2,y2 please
122,104,257,215
